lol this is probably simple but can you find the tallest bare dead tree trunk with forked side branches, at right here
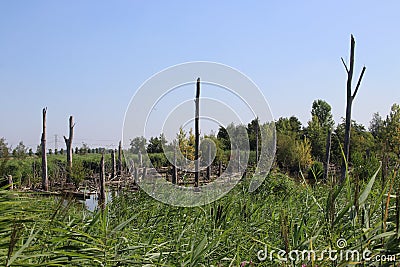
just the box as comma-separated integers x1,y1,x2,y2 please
340,35,366,182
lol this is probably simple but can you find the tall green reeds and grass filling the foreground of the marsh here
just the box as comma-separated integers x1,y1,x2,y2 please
0,164,400,266
